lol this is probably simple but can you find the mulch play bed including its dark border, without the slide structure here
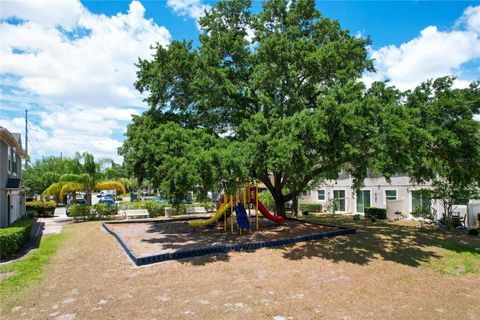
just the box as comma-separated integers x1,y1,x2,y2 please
103,218,355,265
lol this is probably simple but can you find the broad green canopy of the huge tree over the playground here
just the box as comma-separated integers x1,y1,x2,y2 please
119,0,478,214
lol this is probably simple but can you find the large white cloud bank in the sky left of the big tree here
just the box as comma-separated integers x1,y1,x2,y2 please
0,0,171,160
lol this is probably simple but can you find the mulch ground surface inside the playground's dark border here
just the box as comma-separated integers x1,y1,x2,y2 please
108,219,338,257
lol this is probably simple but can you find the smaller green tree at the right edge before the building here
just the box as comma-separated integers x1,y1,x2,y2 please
405,77,480,217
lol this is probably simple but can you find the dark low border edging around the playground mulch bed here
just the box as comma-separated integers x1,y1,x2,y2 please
102,218,357,266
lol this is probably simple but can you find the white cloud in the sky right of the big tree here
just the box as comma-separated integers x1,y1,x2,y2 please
365,6,480,90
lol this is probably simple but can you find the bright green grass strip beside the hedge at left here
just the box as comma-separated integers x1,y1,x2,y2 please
0,233,69,302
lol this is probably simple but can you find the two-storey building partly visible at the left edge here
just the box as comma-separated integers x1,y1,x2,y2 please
0,127,27,228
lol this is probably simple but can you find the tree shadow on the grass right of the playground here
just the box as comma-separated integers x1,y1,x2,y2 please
282,217,480,267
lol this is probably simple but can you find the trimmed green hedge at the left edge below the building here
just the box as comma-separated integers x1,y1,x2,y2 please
0,219,32,258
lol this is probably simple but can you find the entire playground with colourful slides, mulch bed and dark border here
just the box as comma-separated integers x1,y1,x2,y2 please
102,183,356,266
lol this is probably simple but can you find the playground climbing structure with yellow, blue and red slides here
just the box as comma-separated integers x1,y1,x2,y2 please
188,182,283,234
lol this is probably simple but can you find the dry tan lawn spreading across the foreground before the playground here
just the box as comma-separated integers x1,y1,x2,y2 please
2,222,480,320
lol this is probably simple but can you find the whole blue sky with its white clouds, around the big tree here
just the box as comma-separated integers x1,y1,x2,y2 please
0,0,480,161
